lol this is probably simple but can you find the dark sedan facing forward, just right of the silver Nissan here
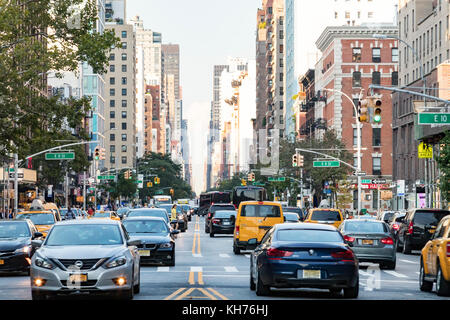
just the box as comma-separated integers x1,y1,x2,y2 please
123,217,180,266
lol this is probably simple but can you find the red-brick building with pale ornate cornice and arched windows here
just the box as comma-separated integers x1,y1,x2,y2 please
314,24,398,212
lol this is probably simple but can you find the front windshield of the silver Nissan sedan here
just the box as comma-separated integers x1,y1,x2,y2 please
45,224,123,246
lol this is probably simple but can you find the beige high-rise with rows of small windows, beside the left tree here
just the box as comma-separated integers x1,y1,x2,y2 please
105,24,136,169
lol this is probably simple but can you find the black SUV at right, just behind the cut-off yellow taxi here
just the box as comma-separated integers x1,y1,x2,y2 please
397,209,450,254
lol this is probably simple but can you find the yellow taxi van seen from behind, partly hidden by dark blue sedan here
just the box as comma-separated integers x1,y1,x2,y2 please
233,201,284,254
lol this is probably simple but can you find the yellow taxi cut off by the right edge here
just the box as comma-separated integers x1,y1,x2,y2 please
419,215,450,296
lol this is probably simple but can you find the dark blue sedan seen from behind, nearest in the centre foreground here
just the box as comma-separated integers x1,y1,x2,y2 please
250,223,359,298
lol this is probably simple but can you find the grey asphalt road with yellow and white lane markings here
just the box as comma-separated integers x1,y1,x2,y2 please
0,216,450,300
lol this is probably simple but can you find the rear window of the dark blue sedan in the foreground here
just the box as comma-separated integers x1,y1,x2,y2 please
276,229,344,243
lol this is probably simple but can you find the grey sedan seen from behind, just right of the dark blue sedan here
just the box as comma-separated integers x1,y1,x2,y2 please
338,219,397,270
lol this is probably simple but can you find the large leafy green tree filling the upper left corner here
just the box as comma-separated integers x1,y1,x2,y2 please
0,0,120,184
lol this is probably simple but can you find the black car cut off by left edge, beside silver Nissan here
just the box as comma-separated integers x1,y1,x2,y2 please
0,220,42,273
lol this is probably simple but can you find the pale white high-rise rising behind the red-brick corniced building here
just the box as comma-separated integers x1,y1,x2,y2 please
284,0,398,137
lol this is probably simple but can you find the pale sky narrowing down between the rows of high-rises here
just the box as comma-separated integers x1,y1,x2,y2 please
126,0,262,195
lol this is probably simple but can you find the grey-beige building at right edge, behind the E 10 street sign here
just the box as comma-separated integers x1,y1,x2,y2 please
392,0,450,209
